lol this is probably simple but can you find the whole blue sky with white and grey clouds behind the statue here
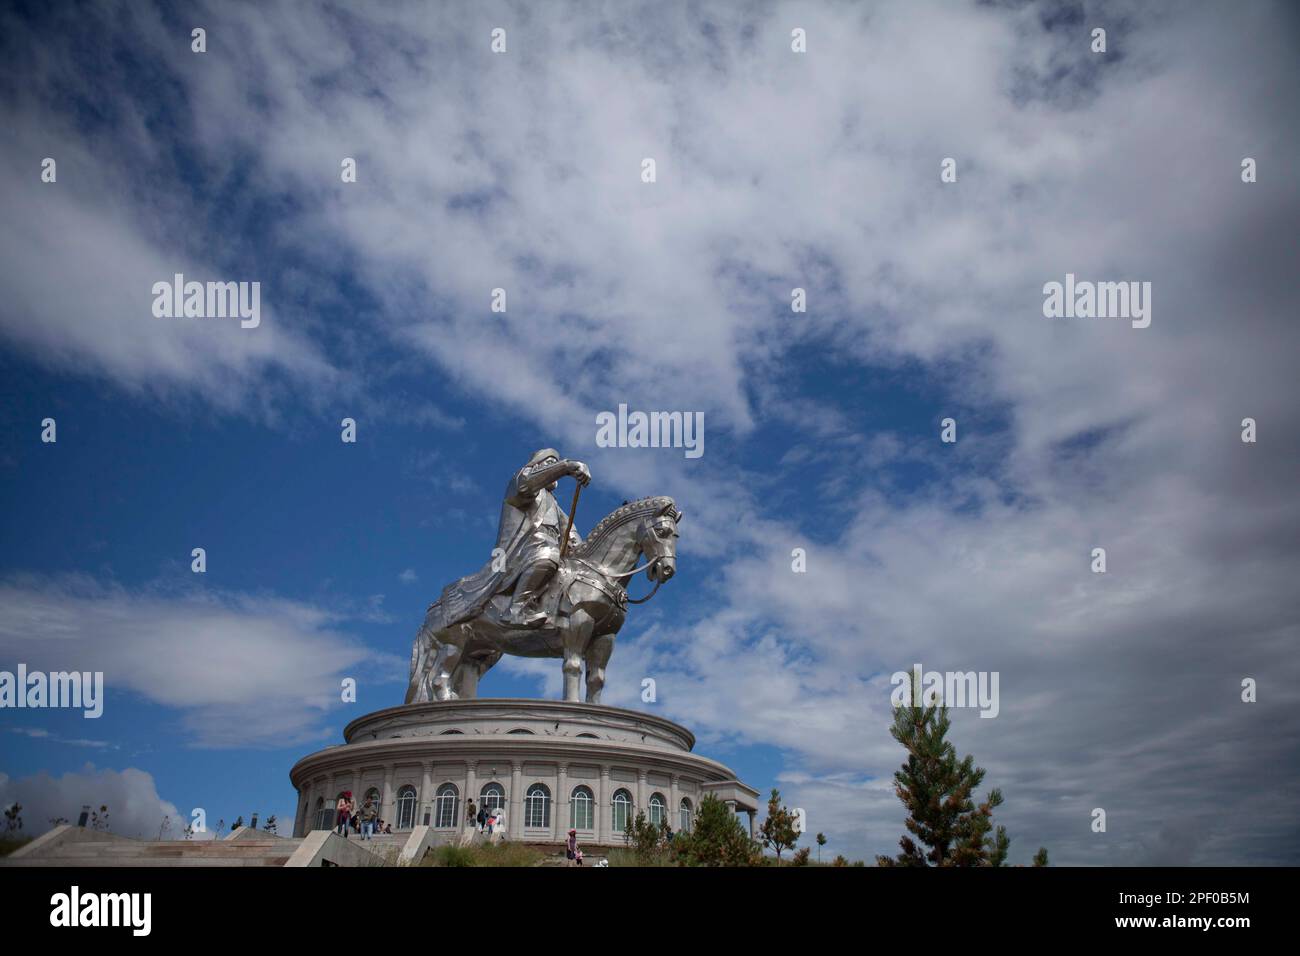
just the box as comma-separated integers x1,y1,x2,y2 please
0,1,1300,865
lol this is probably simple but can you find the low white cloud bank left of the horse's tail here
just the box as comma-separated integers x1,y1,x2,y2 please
0,576,406,747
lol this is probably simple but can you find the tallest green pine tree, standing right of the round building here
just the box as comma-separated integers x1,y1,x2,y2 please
876,682,1010,866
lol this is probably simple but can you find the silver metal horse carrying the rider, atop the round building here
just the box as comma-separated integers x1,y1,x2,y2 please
406,489,683,704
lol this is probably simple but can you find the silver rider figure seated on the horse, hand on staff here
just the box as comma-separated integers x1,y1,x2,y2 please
497,449,592,627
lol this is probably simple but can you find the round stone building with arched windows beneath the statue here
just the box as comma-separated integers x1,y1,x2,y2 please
289,698,758,845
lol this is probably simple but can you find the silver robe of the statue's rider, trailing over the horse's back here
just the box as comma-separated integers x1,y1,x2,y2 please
425,467,581,631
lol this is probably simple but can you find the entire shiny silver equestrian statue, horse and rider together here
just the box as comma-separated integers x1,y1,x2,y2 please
407,449,683,704
